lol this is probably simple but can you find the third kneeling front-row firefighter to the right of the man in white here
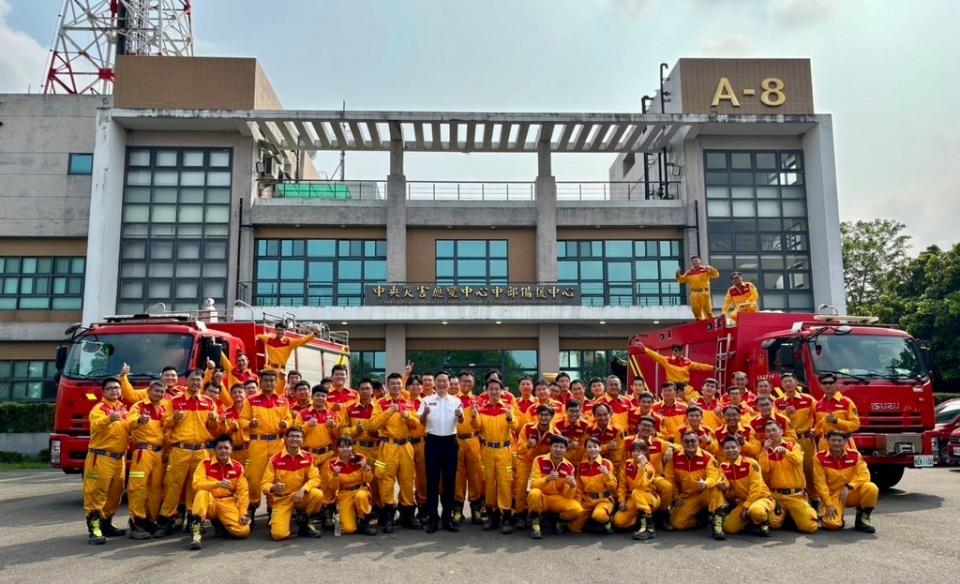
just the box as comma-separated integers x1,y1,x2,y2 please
613,438,660,541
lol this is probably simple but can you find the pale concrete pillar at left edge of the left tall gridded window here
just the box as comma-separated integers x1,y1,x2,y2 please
83,108,127,324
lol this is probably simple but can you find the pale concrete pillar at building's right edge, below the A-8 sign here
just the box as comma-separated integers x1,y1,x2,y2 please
803,115,847,314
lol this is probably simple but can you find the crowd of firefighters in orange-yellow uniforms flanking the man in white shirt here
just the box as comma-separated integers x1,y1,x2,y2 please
83,326,878,549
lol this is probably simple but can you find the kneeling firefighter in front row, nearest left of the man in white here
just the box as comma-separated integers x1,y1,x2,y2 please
321,436,377,535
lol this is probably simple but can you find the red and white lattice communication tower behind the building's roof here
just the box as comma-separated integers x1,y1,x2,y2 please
43,0,193,94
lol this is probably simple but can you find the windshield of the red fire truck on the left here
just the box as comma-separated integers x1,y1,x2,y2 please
63,334,193,379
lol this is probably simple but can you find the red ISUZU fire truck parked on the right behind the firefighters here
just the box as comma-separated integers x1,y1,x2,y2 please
627,312,938,489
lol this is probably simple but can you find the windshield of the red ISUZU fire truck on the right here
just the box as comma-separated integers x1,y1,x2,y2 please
809,334,927,380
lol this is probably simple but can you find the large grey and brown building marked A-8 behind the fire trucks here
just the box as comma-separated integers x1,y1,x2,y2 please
0,57,844,400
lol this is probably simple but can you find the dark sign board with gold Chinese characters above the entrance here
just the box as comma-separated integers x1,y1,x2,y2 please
363,283,580,306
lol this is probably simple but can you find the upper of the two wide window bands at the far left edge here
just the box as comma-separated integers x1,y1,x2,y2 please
0,257,86,310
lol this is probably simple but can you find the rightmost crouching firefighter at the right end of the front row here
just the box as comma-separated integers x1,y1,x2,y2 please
813,430,880,533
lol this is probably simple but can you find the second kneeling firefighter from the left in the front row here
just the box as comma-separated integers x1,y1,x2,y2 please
260,426,323,541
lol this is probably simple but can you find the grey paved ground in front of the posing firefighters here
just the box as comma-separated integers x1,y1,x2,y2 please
0,469,960,584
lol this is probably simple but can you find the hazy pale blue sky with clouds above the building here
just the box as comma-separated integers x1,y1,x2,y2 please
0,0,960,251
